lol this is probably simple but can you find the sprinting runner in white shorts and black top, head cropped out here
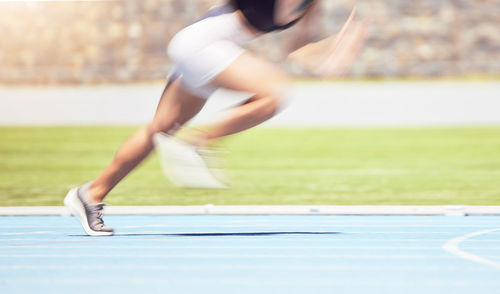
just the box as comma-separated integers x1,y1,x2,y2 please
64,0,366,236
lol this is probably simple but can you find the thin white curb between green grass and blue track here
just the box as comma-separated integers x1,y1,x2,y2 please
0,205,500,216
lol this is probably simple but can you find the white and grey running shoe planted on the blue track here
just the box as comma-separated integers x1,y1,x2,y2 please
64,188,114,236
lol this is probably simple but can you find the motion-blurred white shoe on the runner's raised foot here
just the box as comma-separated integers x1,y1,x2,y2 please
153,133,227,189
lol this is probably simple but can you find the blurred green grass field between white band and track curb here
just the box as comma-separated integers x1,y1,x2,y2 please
0,127,500,206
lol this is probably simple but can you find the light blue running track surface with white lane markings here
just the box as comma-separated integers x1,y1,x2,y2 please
0,216,500,294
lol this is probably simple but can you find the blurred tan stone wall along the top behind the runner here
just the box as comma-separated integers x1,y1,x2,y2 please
0,0,500,85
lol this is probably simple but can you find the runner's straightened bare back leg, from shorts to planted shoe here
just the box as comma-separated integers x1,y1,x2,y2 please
88,80,205,203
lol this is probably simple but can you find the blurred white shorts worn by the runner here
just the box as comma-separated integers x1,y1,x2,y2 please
168,5,257,99
